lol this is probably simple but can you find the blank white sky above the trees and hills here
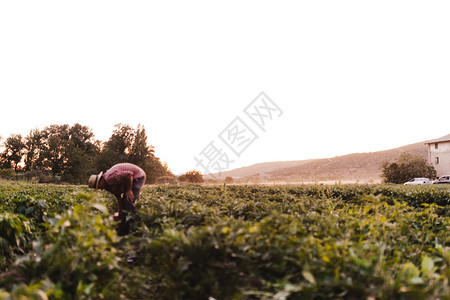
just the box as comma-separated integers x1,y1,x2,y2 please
0,0,450,174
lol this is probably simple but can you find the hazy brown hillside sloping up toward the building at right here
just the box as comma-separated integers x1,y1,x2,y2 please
205,142,427,182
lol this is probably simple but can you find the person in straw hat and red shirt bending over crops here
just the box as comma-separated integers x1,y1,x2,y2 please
89,163,147,235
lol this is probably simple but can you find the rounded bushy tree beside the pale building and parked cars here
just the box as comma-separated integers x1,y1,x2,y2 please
381,152,436,183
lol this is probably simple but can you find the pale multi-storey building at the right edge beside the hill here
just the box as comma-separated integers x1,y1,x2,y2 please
425,134,450,177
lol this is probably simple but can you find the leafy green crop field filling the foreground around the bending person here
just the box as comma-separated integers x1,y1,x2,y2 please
0,182,450,299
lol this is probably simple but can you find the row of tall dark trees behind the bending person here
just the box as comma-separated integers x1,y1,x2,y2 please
0,123,174,184
